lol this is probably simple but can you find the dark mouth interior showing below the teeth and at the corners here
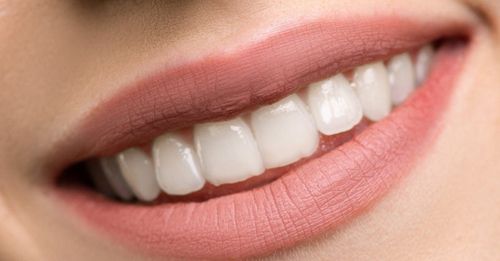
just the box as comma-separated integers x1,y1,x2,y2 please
56,38,457,204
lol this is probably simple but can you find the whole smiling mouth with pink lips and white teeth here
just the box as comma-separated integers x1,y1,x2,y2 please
49,17,471,259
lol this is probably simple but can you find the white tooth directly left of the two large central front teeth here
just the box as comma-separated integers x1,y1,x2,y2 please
153,133,205,195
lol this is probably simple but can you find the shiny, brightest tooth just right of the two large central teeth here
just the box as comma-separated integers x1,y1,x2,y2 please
307,74,363,135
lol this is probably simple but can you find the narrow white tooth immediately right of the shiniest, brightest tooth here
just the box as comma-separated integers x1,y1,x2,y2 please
354,62,391,121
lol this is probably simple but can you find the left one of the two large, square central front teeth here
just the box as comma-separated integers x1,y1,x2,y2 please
194,118,264,185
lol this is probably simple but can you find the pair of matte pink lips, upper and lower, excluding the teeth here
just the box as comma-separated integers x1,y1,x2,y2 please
54,18,471,259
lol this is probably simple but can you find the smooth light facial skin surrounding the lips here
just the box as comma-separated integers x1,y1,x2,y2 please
0,0,500,260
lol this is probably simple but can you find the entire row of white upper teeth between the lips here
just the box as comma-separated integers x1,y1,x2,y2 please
91,46,433,201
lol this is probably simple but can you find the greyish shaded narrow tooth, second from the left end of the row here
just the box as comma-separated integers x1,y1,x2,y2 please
117,148,160,201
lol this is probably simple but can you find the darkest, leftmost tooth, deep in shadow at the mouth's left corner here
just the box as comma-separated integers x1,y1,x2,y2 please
88,158,134,200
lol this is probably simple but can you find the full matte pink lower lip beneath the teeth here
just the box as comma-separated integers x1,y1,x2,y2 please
54,42,466,259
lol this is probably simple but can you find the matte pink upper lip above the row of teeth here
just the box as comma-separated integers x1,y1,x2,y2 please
48,17,472,170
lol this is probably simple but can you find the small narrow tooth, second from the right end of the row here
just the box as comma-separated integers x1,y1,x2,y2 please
387,53,416,105
